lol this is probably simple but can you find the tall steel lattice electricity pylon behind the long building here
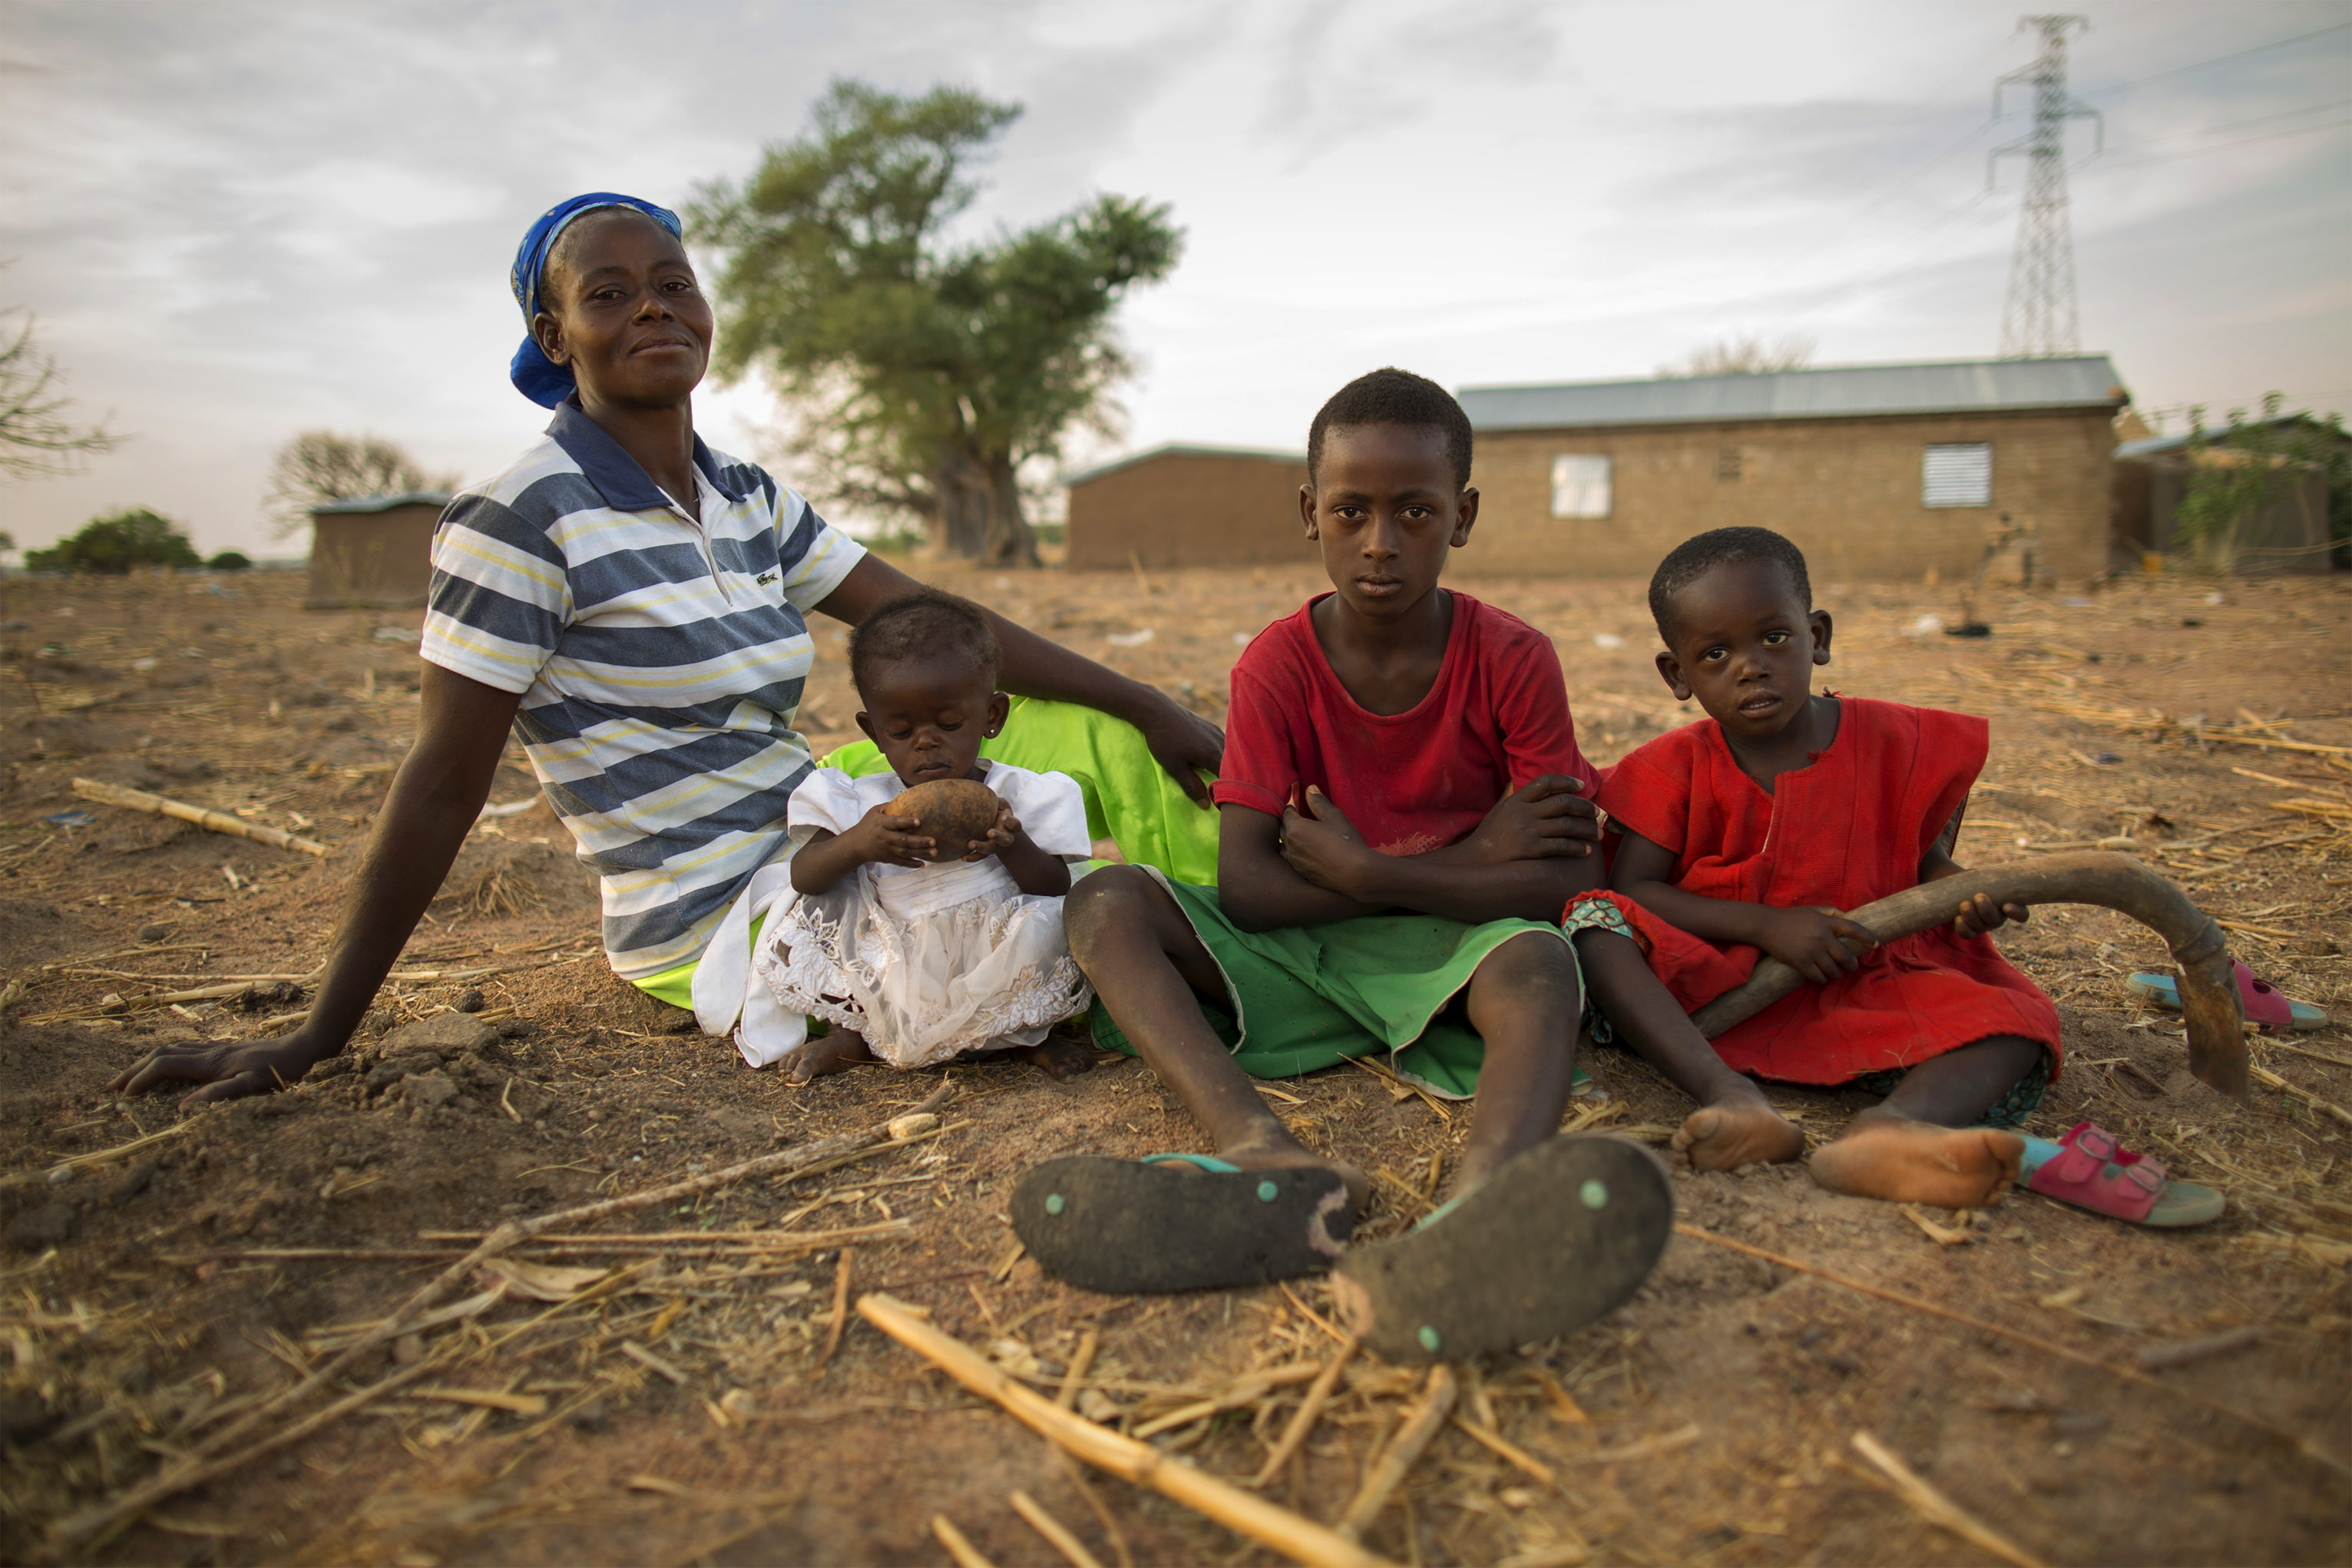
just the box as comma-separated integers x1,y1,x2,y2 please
1985,16,2107,359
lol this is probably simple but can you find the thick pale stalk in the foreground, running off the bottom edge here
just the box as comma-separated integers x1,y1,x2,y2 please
858,1293,1394,1568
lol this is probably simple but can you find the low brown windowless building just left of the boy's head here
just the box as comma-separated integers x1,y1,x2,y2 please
1063,447,1317,571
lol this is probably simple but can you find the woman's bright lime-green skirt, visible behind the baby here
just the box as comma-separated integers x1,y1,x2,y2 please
819,696,1216,886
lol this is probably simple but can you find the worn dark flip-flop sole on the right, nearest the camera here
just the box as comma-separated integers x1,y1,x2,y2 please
1331,1138,1675,1364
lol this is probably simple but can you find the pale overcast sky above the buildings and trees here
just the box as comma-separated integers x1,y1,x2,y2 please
0,0,2352,552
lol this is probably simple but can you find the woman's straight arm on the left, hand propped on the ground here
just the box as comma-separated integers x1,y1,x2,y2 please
108,663,522,1103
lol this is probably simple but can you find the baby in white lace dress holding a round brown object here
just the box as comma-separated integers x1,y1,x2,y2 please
753,590,1093,1083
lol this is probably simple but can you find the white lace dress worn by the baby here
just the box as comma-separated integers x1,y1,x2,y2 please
753,762,1093,1067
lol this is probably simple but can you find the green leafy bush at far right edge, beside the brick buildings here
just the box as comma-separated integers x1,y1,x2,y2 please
2173,392,2352,574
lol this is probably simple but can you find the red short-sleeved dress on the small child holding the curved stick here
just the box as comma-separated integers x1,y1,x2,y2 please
1599,696,2058,1083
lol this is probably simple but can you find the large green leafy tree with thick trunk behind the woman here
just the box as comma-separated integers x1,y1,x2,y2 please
694,80,1183,567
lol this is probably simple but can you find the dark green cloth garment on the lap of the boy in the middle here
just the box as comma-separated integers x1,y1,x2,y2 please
1091,882,1576,1100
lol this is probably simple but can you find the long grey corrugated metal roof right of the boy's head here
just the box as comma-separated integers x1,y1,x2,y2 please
1458,355,2129,430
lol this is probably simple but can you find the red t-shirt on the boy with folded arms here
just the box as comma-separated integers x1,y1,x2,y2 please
1211,590,1599,855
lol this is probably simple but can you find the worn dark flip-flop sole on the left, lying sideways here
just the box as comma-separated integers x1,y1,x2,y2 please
1011,1154,1355,1295
